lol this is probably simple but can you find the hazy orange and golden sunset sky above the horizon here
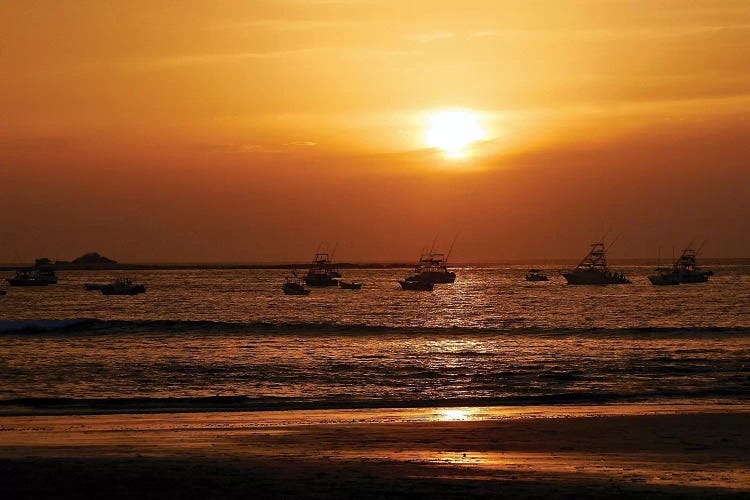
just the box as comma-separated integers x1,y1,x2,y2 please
0,0,750,262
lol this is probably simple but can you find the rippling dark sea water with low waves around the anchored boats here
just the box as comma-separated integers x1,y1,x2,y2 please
0,266,750,409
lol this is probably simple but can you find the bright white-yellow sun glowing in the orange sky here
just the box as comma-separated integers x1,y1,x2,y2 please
425,111,485,158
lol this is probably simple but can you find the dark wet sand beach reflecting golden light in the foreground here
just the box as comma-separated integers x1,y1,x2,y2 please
0,405,750,498
